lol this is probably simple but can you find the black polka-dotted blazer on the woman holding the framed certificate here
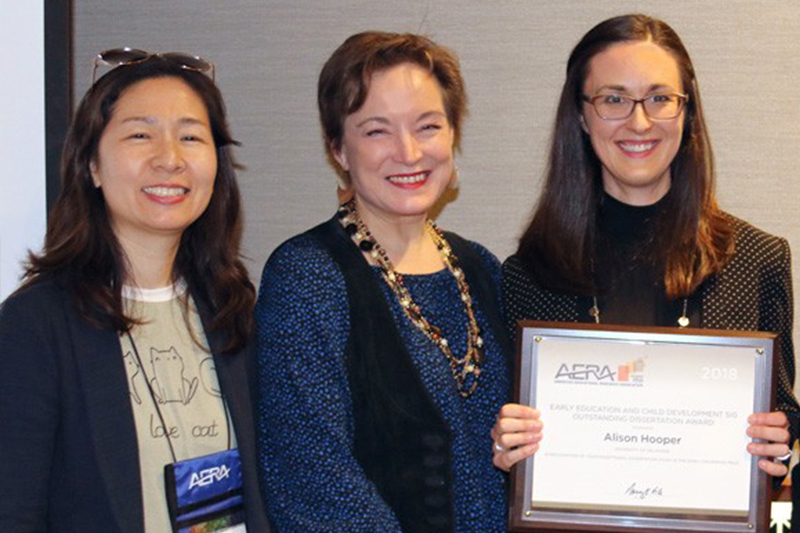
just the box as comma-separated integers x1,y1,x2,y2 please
503,214,800,438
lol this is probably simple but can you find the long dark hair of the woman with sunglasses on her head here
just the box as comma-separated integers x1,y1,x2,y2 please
25,56,255,351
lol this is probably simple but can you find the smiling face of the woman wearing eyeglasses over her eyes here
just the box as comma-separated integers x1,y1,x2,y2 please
583,41,684,205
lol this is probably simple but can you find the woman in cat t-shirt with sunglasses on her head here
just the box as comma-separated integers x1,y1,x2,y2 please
0,49,268,533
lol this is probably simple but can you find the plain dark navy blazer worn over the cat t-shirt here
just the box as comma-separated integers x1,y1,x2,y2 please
0,281,268,533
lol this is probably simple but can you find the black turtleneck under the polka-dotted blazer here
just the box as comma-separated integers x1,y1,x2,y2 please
581,189,699,327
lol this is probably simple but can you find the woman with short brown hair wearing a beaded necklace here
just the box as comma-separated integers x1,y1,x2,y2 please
256,32,508,533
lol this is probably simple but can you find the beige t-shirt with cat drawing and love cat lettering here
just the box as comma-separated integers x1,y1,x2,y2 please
120,284,236,532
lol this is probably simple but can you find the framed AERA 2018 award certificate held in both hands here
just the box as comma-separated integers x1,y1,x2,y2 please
510,322,776,533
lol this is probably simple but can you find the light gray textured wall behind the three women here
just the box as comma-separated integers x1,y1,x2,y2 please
75,0,800,340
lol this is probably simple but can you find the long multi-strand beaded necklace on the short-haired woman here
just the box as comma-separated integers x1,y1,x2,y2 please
337,200,483,398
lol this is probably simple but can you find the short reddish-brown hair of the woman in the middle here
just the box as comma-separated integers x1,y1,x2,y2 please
317,31,467,185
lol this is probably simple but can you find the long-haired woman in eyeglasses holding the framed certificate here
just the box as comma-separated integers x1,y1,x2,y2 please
493,15,798,475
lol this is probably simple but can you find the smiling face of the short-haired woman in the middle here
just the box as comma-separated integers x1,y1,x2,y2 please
334,63,454,224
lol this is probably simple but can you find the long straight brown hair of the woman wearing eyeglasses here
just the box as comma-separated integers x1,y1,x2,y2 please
517,15,733,299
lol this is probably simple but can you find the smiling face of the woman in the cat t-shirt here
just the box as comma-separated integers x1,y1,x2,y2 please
91,77,217,245
